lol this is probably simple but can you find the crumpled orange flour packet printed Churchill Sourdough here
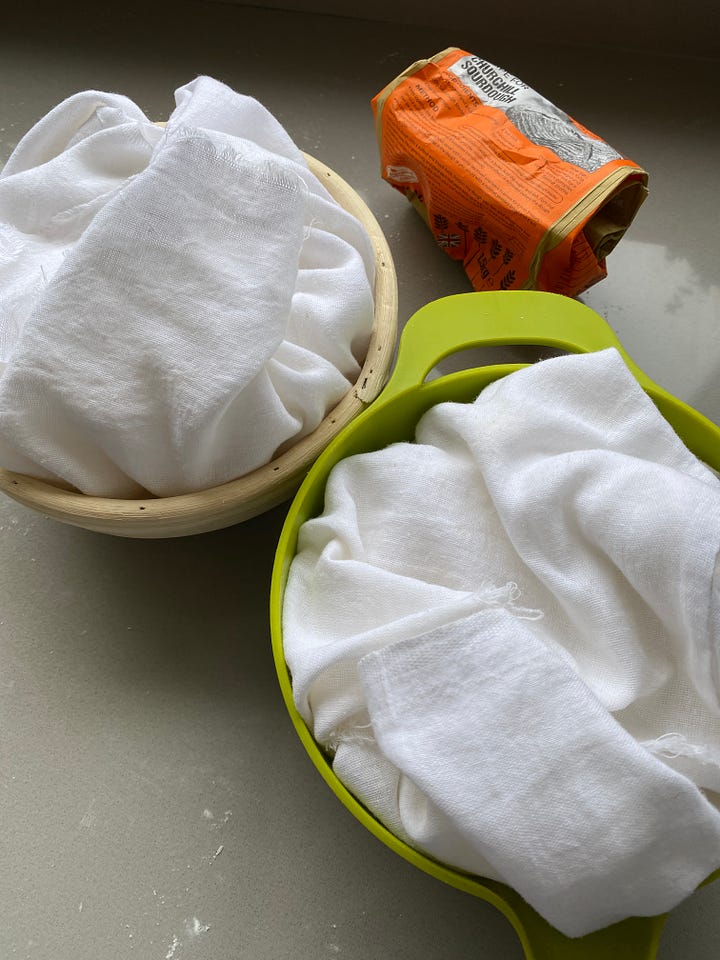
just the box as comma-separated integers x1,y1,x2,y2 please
372,47,648,296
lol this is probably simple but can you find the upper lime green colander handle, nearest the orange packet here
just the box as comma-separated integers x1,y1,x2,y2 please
383,290,660,400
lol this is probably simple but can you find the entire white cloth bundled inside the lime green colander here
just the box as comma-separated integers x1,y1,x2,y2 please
283,350,720,936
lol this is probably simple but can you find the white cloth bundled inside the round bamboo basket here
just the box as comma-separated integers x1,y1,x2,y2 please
0,77,374,497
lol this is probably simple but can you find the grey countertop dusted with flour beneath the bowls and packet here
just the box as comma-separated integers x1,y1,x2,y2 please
0,2,720,960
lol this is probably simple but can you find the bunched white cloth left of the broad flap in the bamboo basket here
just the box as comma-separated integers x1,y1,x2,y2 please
0,90,162,360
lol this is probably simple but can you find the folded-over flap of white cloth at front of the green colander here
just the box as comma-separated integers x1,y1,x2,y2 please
359,609,720,936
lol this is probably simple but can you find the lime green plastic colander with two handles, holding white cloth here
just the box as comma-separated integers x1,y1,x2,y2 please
270,291,720,960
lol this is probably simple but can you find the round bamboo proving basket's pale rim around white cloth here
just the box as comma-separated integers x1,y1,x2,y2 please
0,154,397,539
